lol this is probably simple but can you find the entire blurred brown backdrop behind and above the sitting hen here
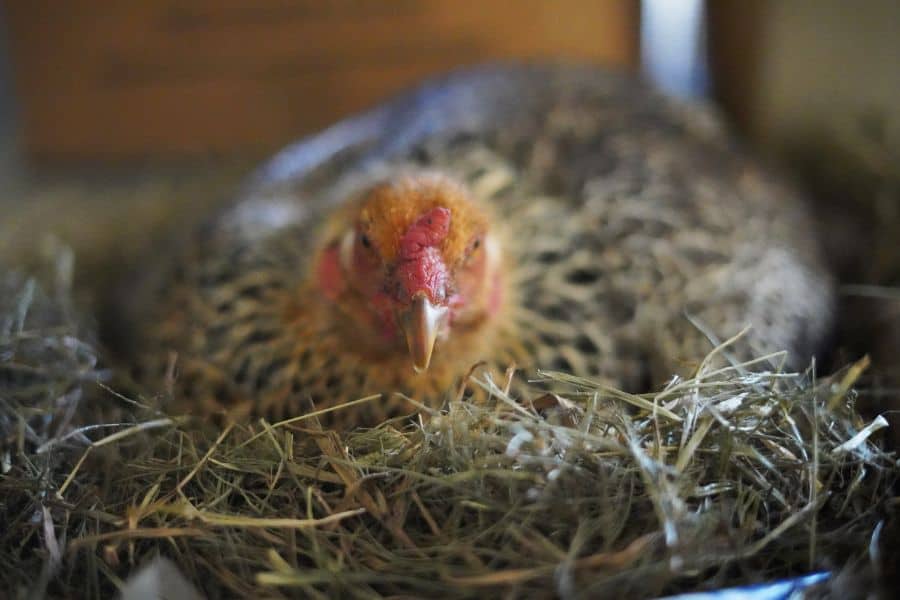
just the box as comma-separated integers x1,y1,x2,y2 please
0,0,900,370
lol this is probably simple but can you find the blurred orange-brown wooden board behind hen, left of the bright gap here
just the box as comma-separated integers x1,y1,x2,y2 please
3,0,638,160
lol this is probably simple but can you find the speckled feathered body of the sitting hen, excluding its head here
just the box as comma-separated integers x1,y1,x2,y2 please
130,66,833,421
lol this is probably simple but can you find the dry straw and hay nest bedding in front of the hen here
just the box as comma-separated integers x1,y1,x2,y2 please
0,254,898,598
